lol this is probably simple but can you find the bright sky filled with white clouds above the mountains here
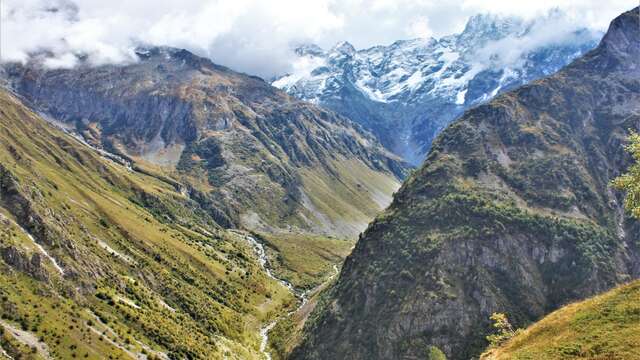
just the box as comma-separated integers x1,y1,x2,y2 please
0,0,638,78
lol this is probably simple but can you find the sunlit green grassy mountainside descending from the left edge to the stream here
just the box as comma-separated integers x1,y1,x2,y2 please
0,89,295,359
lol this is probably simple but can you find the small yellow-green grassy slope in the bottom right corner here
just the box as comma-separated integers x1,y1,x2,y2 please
482,281,640,360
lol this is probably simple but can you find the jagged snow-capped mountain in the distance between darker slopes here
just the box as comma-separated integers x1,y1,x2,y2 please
273,12,601,164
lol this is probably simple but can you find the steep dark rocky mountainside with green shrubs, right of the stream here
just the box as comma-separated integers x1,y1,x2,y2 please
292,8,640,359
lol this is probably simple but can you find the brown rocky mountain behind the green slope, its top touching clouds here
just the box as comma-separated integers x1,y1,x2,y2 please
5,48,405,237
